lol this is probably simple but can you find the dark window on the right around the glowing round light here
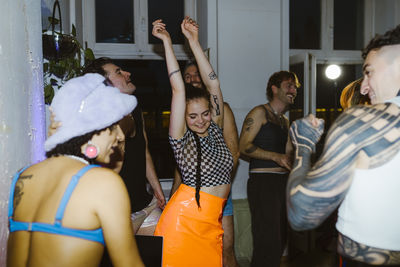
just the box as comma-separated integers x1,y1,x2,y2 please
289,0,373,128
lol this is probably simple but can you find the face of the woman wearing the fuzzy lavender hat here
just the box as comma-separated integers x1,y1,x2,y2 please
86,124,125,164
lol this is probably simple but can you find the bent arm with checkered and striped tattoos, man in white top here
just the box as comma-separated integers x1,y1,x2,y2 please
287,103,400,230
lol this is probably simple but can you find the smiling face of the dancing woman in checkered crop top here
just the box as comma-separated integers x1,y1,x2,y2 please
186,98,211,137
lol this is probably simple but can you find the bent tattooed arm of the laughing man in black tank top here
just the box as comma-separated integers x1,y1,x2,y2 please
239,106,291,170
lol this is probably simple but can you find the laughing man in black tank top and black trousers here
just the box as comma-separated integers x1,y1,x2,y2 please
239,71,300,267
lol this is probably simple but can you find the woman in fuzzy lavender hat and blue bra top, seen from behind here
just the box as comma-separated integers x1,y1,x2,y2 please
7,74,144,267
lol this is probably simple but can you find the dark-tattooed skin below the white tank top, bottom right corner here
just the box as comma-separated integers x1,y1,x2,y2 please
338,234,400,266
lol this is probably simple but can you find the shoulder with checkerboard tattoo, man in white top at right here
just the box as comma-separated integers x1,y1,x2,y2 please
326,103,400,168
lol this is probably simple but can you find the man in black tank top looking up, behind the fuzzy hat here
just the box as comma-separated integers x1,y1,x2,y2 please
84,57,165,234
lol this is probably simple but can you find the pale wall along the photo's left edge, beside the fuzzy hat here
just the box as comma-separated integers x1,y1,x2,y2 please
0,0,44,266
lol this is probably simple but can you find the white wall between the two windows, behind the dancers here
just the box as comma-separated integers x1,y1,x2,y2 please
217,0,287,199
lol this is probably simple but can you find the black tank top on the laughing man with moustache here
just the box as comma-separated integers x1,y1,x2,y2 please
249,105,288,170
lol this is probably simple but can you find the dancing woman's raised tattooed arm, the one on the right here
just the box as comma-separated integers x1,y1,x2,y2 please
181,17,224,128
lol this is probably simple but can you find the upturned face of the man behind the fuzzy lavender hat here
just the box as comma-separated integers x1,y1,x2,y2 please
103,63,136,95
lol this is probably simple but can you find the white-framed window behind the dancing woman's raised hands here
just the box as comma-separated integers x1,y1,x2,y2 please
82,0,196,59
